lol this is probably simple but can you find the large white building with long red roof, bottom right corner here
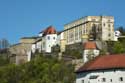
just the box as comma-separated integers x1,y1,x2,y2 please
76,54,125,83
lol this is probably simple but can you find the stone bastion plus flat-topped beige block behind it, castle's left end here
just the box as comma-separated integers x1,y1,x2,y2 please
9,37,38,64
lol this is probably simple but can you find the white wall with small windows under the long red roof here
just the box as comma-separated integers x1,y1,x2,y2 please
76,69,125,83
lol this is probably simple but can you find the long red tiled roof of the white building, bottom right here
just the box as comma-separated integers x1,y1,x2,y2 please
76,54,125,72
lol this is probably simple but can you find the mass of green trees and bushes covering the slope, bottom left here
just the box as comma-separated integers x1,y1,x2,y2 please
0,54,75,83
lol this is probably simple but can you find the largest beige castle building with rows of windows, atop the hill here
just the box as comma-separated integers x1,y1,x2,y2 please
64,16,114,45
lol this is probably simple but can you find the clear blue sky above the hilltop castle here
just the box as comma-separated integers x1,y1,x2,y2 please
0,0,125,44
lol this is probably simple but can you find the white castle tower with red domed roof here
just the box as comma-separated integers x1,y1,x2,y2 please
42,26,57,53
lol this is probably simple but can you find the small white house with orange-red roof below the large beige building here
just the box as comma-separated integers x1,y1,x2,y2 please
83,41,99,62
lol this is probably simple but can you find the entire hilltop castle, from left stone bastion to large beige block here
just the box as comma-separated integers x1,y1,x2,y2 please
10,16,117,63
